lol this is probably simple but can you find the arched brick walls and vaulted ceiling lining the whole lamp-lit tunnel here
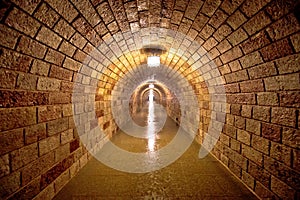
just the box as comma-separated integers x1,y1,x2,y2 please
0,0,300,199
